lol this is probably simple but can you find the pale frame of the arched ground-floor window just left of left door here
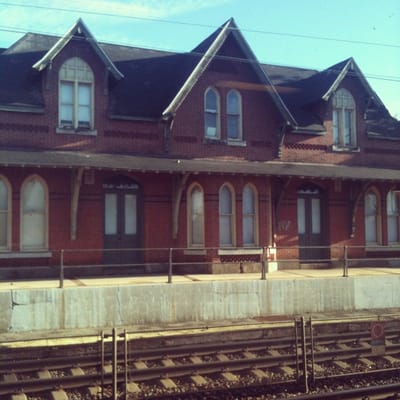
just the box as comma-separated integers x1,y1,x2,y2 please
20,175,49,251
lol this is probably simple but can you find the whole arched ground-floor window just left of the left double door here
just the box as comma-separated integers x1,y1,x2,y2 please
21,175,48,250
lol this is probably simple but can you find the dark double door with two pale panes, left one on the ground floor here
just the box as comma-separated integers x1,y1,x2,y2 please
103,176,143,266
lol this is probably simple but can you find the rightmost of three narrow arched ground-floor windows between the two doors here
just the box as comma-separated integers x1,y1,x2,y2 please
242,185,258,246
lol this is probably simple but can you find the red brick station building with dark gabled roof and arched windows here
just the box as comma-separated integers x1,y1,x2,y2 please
0,20,400,272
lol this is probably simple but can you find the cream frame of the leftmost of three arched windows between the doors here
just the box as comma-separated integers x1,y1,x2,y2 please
186,183,205,248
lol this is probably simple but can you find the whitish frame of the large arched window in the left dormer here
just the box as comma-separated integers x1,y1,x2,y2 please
57,57,97,135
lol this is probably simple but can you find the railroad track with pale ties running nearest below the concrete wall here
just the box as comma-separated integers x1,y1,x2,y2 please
0,318,400,399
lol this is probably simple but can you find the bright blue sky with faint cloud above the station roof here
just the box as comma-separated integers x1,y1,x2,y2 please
0,0,400,119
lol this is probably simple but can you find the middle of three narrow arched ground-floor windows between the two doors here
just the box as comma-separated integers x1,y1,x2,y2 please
219,184,236,246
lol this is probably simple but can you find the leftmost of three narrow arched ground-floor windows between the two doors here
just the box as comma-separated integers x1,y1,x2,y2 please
187,184,204,247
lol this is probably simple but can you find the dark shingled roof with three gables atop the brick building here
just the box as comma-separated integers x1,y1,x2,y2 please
0,20,400,137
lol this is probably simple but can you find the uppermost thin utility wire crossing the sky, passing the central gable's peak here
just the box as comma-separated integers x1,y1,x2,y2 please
0,1,400,48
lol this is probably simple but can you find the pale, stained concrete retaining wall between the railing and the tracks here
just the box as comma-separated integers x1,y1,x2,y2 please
0,276,400,333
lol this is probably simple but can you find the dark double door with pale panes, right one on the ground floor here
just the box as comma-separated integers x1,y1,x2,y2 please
297,186,328,262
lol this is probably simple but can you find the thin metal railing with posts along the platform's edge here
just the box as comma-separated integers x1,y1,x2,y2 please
0,245,400,288
